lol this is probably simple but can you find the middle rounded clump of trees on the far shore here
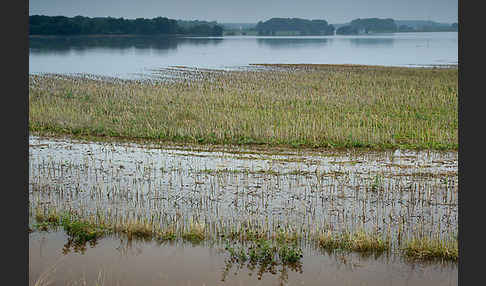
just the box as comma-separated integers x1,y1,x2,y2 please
255,18,334,35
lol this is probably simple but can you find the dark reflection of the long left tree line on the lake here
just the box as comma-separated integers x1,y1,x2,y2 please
29,36,223,54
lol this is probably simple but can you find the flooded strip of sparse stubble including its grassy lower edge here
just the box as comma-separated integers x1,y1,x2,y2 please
29,136,458,260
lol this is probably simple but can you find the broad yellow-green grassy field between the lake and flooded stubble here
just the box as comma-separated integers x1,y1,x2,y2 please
29,65,458,150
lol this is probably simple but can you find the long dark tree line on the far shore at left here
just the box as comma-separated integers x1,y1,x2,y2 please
29,15,223,36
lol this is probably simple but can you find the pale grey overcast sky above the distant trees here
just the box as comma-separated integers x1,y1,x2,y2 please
29,0,458,24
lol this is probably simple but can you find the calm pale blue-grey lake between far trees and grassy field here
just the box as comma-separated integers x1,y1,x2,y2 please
29,32,458,78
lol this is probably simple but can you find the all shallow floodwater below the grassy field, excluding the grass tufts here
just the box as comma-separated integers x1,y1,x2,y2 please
29,136,458,285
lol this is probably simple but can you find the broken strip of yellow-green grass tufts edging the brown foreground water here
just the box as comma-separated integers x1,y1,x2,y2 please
32,206,458,265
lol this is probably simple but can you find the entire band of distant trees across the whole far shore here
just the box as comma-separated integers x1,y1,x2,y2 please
29,15,458,36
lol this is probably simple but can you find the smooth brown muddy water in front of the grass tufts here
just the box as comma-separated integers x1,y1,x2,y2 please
29,232,458,286
